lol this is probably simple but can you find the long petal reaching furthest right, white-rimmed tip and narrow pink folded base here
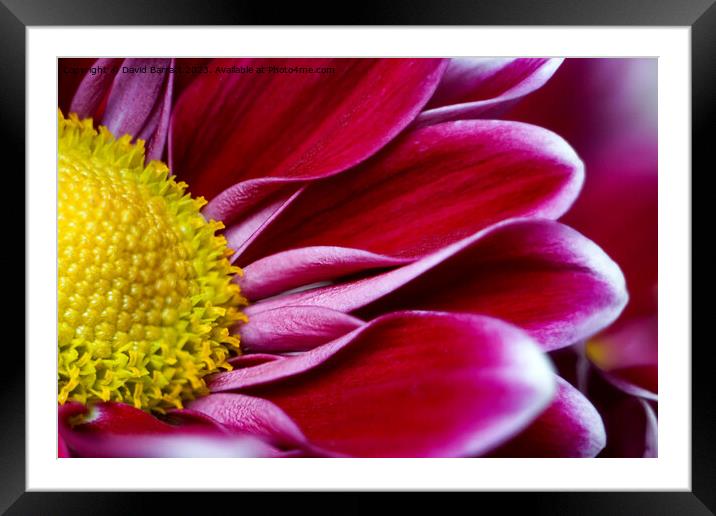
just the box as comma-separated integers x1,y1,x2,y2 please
253,220,627,350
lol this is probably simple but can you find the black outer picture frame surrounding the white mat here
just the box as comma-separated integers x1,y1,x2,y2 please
0,0,704,515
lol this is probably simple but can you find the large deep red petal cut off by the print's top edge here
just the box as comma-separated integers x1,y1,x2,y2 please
170,59,446,204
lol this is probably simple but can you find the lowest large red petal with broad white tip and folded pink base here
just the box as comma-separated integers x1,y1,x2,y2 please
206,312,554,457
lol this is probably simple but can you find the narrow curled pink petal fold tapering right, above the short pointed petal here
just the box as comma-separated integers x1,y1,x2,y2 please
239,246,410,300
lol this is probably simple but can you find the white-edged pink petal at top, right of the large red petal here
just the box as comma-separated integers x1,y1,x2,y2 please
417,58,563,125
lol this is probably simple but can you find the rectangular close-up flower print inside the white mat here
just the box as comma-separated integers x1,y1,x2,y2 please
58,58,658,458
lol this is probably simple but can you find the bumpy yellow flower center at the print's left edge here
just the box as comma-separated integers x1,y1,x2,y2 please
57,113,246,412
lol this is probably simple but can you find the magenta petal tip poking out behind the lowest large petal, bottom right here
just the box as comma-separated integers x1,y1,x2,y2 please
491,377,606,457
